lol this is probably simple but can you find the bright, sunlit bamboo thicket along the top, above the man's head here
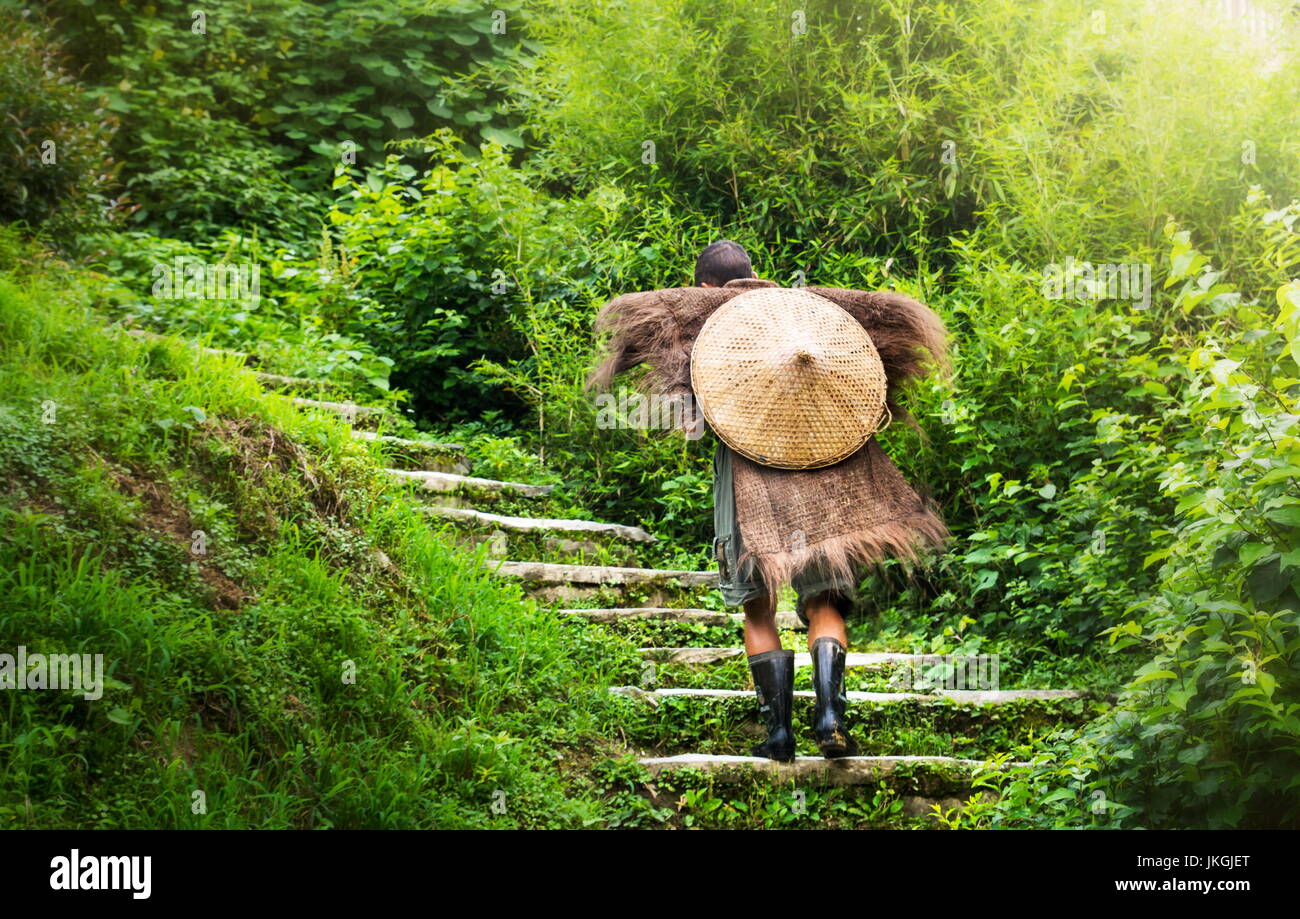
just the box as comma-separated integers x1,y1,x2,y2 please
506,0,1300,266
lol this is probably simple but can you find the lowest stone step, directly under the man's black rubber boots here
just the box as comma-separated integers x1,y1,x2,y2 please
640,753,1024,789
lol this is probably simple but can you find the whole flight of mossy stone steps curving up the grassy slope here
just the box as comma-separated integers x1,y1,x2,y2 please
124,324,1088,818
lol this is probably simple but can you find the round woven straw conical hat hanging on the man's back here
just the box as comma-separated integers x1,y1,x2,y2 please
690,287,888,469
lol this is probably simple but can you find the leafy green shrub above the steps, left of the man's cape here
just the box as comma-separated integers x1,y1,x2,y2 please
329,131,611,420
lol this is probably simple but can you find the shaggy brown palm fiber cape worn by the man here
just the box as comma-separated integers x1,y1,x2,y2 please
588,278,948,602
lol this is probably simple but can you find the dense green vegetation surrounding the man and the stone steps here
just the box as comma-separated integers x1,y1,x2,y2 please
0,0,1300,828
